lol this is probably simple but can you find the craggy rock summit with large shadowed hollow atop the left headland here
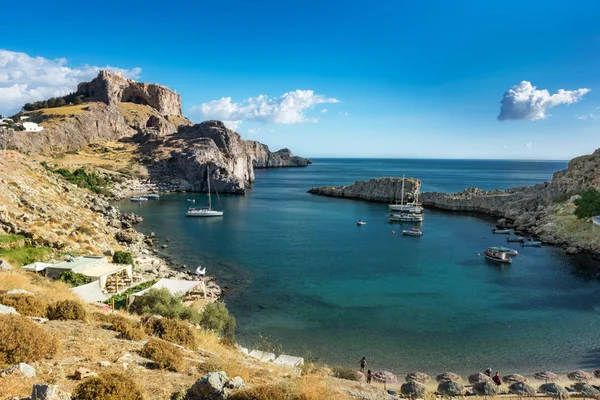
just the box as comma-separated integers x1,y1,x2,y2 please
77,71,183,117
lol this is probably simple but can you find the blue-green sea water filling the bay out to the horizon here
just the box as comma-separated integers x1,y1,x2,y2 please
119,159,600,374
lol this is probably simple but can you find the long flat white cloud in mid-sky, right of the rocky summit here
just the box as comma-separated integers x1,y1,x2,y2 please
192,90,339,124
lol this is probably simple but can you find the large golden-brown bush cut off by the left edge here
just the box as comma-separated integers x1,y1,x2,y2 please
0,315,58,368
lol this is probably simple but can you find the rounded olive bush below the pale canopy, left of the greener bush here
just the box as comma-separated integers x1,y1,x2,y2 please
129,288,201,324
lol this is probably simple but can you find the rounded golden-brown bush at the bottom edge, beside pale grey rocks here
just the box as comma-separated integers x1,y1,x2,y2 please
73,372,144,400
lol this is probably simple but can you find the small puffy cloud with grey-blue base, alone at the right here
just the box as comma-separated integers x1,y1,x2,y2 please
498,81,590,121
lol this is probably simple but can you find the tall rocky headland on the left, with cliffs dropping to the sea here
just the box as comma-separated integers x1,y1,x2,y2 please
0,71,310,194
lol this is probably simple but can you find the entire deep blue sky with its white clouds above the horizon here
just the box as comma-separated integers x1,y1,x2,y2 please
0,0,600,160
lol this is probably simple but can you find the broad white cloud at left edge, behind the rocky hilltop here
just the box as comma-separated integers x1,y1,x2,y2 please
0,49,142,115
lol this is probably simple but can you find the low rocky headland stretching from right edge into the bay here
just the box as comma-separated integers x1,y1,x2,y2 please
309,149,600,253
